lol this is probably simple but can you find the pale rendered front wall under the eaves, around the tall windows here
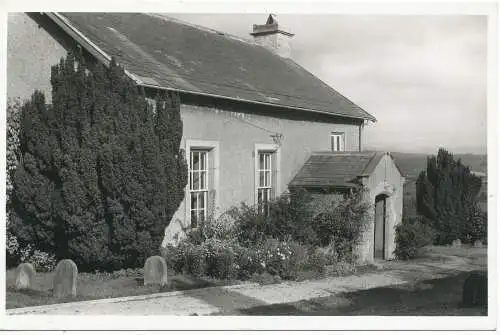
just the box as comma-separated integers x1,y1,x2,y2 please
164,105,359,243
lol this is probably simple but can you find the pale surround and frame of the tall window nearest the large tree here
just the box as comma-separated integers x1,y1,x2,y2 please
184,140,219,229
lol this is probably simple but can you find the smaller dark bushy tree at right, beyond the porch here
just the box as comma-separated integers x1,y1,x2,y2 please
417,148,481,244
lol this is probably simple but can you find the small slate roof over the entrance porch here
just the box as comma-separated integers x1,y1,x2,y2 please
288,151,386,188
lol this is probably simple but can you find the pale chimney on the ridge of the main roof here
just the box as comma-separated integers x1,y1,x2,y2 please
250,14,294,58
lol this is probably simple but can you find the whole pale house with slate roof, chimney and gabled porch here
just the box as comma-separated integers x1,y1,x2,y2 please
8,13,403,261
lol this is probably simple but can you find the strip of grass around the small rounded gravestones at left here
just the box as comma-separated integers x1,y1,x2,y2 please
6,269,235,309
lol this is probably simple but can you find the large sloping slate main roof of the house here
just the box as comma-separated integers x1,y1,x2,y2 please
47,13,375,121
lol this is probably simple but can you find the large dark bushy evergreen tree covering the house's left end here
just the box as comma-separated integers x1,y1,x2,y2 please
12,54,187,270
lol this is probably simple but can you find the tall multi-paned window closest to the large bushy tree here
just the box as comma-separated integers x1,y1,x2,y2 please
189,149,209,228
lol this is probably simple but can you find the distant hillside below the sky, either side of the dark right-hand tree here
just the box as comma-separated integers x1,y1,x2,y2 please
391,152,487,180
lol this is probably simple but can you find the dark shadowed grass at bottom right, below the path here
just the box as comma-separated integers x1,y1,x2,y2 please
230,272,487,316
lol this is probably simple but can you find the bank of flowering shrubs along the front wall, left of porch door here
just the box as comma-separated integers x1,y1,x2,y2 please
162,192,368,280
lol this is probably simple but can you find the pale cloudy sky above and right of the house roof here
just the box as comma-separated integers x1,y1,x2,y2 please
168,14,487,153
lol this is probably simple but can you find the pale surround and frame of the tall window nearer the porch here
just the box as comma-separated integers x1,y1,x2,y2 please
253,144,281,211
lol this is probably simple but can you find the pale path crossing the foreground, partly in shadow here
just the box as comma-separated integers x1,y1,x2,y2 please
7,257,481,315
